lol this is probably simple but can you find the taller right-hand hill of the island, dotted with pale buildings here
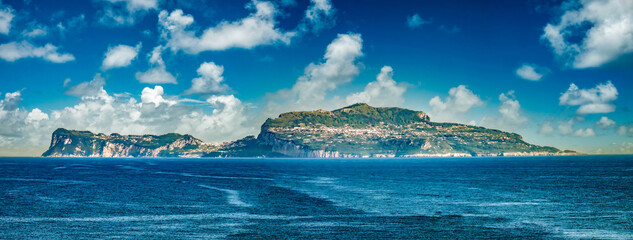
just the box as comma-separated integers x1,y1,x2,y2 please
258,103,563,157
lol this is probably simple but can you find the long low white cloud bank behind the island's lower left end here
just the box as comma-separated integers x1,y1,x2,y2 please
0,86,258,155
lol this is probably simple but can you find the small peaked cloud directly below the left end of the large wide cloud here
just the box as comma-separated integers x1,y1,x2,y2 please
136,45,177,84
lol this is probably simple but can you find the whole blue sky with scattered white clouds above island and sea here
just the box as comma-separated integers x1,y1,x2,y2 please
0,0,633,155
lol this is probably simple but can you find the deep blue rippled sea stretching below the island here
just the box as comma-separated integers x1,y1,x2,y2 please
0,156,633,239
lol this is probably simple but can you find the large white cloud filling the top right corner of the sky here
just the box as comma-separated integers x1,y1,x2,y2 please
542,0,633,68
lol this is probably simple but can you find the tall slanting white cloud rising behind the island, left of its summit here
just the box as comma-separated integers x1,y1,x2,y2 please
265,33,363,115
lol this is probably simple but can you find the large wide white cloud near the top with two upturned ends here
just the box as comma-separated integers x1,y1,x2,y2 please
158,0,296,54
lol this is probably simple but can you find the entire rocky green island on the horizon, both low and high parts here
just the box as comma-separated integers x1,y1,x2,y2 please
42,103,579,158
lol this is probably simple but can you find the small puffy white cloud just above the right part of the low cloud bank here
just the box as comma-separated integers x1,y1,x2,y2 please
185,62,228,94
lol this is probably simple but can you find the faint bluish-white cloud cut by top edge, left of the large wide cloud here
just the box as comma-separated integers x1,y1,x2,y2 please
95,0,158,26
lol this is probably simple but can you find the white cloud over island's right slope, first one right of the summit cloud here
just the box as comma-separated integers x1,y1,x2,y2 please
429,85,483,122
